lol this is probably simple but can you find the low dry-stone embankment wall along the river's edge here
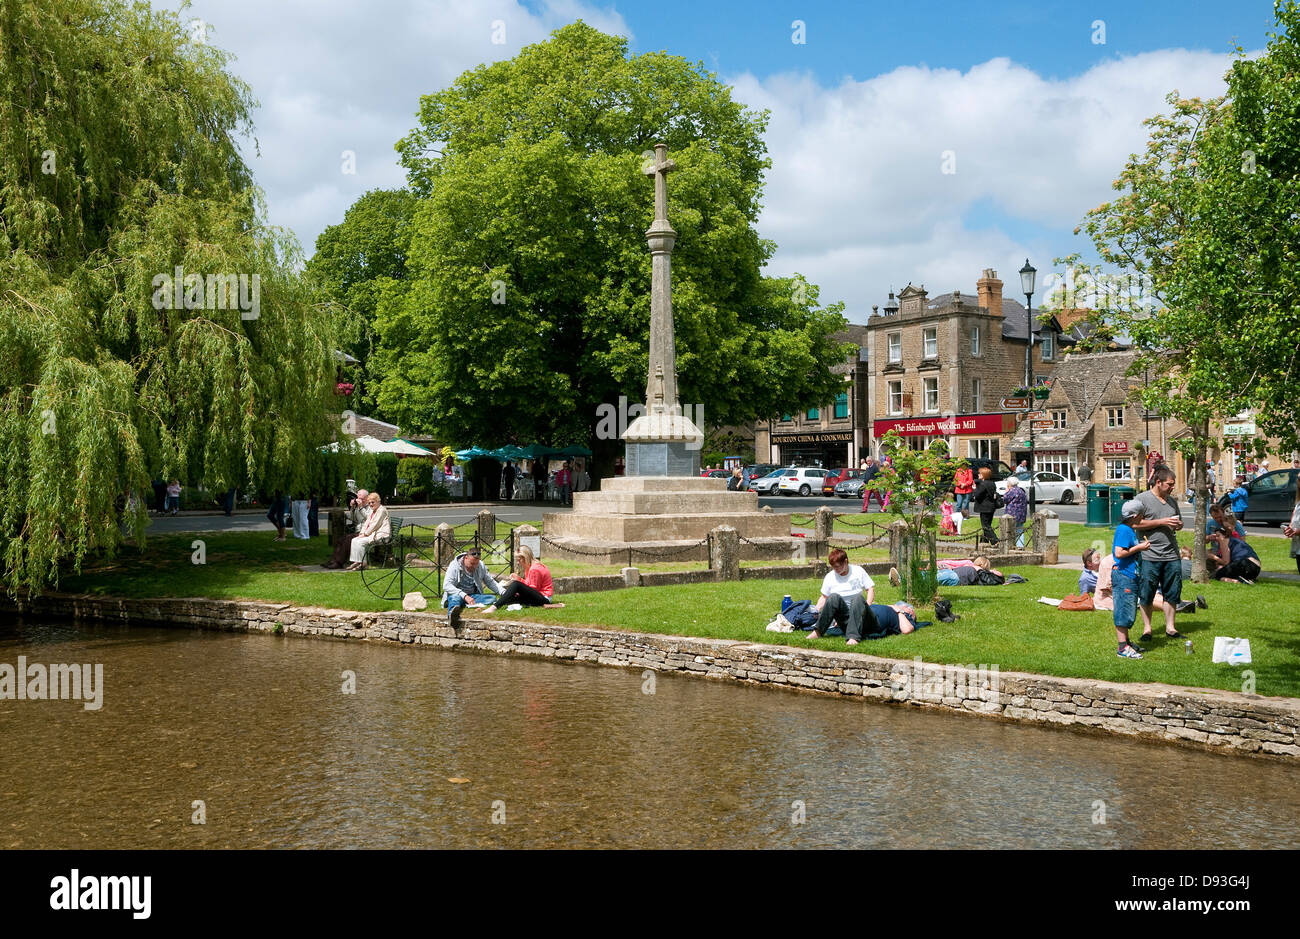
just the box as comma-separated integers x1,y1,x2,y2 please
3,594,1300,762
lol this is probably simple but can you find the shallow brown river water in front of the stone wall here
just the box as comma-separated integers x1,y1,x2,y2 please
0,620,1300,848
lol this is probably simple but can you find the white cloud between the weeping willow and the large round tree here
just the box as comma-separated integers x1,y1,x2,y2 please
160,0,631,256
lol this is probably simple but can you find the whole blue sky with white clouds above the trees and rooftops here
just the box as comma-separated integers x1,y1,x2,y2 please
163,0,1273,321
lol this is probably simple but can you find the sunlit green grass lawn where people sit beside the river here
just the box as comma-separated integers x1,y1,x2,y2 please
50,524,1300,697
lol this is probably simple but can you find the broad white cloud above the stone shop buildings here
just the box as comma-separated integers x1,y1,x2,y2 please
729,49,1231,321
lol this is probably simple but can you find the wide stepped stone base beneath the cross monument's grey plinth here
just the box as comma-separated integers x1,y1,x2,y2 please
542,476,805,564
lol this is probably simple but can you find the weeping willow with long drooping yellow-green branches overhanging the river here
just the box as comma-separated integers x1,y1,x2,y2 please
0,0,351,588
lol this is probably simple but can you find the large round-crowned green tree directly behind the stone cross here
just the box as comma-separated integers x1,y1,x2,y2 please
374,22,845,466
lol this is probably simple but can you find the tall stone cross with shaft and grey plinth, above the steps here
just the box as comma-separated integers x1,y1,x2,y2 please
623,143,705,476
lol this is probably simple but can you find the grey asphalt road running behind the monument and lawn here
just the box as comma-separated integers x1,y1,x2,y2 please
150,496,1282,537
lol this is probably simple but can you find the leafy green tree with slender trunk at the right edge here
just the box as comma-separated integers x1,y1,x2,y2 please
1063,0,1300,580
